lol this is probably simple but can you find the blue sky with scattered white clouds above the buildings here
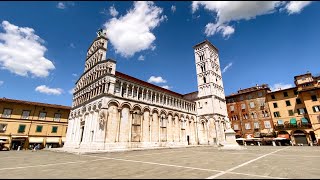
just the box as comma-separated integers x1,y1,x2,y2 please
0,1,320,106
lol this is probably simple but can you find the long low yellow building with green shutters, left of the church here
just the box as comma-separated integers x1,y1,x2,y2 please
0,98,71,150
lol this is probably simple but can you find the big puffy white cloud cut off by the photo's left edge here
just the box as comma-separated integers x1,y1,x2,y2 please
0,21,55,77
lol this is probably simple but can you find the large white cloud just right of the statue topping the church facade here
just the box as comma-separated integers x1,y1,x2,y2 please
104,1,166,57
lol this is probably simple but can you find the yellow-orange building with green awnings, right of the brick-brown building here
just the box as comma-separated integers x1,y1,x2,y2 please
267,73,320,145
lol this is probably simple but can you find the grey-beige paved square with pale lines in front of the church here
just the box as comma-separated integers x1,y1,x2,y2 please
0,146,320,179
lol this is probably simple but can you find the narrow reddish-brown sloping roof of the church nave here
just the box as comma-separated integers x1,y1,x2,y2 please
116,71,183,98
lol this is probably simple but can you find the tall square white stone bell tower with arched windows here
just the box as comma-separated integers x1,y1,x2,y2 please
193,40,228,145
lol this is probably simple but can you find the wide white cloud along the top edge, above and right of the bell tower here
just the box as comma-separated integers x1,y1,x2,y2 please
191,1,310,37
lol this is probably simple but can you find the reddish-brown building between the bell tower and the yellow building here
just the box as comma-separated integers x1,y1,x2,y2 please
226,84,274,138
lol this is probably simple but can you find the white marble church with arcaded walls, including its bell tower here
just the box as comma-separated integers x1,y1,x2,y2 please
64,30,228,150
